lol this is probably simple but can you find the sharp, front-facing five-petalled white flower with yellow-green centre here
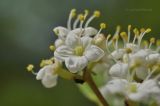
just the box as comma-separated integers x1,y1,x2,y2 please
54,32,104,73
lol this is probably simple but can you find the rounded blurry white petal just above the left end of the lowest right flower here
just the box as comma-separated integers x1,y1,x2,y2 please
109,63,128,78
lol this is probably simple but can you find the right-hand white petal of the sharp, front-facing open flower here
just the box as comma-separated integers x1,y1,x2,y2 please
84,45,104,62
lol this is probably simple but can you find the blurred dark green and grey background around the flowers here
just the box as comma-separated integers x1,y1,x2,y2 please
0,0,160,106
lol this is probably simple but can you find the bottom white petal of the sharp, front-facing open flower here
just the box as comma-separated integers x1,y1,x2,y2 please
65,56,88,73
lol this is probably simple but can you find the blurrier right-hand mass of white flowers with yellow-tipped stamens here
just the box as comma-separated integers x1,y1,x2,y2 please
101,25,160,104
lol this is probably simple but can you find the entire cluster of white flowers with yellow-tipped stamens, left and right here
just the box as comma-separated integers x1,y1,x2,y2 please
27,9,160,106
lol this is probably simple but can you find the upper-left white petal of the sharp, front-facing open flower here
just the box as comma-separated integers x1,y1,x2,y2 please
65,32,80,48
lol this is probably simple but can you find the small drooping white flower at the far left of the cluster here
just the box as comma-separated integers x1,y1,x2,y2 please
36,64,58,88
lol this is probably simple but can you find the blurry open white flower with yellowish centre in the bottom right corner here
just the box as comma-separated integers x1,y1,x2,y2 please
101,79,160,102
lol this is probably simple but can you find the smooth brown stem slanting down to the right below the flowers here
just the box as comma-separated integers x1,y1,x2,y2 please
83,70,108,106
